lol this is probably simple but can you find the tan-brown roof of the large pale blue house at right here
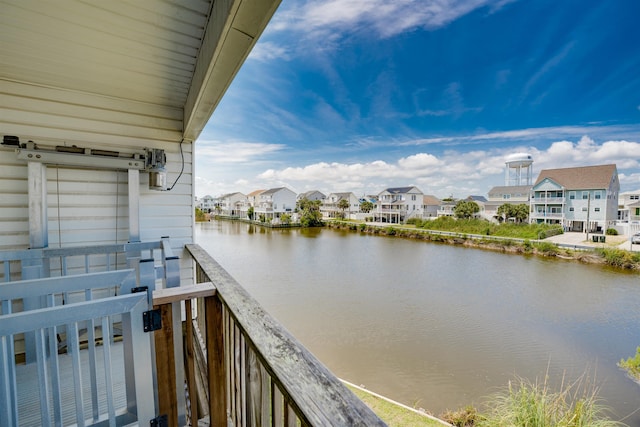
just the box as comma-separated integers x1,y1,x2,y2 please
534,164,618,190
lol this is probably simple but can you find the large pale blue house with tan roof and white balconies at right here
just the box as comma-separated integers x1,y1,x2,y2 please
529,164,620,232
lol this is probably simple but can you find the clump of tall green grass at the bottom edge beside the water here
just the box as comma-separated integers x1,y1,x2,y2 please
475,376,624,427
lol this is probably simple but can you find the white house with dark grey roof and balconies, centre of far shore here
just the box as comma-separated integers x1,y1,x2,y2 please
373,186,424,224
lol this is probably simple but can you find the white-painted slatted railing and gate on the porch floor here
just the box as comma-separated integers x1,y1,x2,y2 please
0,238,185,427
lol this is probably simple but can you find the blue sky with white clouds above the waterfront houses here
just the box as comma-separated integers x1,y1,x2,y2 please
195,0,640,197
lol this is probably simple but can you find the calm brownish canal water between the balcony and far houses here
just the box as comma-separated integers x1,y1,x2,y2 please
196,221,640,426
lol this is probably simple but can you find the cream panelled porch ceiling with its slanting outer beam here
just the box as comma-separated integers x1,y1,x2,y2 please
0,0,280,142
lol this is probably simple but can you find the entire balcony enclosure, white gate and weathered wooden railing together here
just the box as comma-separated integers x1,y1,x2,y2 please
0,239,385,427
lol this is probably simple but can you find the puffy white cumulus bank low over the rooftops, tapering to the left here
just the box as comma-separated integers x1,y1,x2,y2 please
249,136,640,197
